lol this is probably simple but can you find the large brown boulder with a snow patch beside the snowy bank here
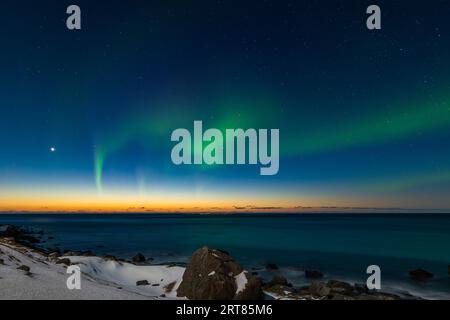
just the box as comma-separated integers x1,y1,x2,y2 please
177,247,262,300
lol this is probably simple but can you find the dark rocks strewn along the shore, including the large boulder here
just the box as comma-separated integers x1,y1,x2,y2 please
0,226,444,300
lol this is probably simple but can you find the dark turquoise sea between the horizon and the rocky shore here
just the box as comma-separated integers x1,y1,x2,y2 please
0,214,450,298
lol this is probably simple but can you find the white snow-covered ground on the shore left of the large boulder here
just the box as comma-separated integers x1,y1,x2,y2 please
0,240,184,300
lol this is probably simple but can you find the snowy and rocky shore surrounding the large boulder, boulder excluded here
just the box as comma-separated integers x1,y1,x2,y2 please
0,225,436,300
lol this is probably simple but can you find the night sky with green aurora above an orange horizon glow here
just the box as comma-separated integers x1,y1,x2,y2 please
0,0,450,212
